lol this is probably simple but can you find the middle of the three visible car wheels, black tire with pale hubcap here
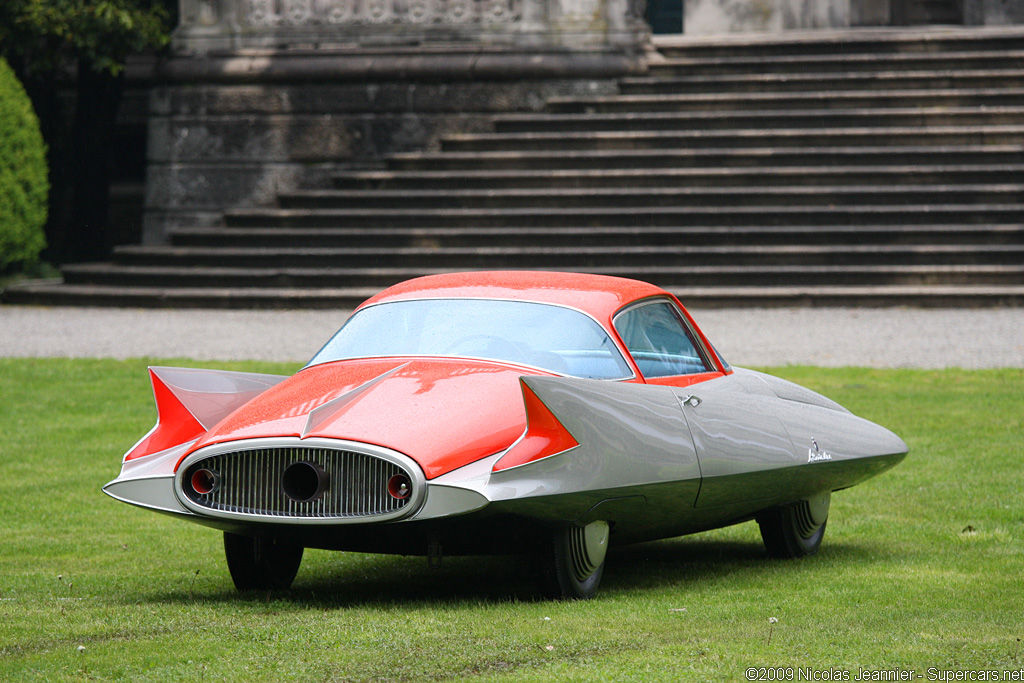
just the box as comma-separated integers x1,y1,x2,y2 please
545,521,608,600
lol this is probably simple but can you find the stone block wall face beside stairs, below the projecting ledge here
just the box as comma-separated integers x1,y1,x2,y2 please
143,69,629,244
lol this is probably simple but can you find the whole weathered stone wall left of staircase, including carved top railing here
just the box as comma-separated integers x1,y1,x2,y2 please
143,0,649,244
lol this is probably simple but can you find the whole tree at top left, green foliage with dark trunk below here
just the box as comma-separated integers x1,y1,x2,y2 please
0,0,176,262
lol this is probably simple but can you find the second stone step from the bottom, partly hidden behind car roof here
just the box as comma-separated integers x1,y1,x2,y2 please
65,263,1024,288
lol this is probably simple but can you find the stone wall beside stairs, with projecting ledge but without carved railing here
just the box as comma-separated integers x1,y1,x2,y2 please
143,49,644,244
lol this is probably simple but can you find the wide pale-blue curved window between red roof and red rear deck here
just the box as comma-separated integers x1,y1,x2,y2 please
309,299,633,380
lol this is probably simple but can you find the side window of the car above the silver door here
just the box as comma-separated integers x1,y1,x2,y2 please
614,300,712,377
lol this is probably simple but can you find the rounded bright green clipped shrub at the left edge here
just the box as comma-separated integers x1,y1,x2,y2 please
0,58,50,271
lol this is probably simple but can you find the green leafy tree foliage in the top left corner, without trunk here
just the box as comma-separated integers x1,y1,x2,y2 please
0,0,170,75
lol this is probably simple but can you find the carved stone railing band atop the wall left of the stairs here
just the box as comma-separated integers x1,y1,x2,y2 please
175,0,649,53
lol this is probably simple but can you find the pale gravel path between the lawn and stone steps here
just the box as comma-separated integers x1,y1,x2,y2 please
0,306,1024,369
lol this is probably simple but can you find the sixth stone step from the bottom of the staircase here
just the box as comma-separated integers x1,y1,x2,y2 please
278,184,1024,210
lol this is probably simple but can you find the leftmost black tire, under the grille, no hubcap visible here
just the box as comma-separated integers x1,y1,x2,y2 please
224,531,302,591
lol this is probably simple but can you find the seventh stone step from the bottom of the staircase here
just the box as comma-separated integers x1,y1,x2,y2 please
333,164,1024,190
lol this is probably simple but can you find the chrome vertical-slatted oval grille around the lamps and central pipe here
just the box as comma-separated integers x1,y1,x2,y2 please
181,446,413,519
